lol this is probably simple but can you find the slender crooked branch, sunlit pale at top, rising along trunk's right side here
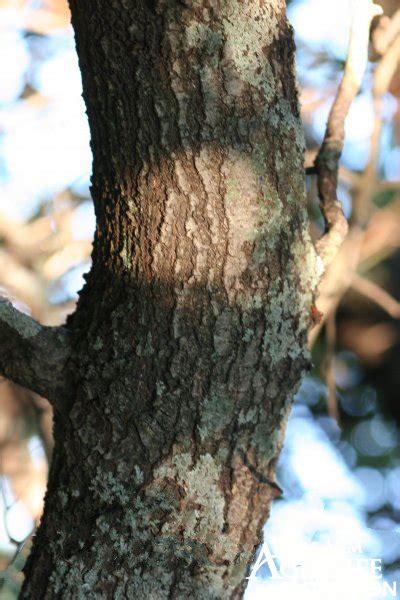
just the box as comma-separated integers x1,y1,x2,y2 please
315,0,381,267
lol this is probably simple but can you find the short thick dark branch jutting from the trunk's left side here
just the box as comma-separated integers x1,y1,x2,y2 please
0,300,69,404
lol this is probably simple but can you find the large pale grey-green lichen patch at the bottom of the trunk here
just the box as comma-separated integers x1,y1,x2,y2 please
41,449,241,600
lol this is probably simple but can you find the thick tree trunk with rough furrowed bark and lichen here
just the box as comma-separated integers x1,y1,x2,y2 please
21,0,318,600
